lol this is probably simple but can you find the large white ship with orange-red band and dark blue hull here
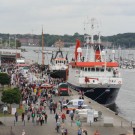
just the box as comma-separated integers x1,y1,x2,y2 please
67,19,122,106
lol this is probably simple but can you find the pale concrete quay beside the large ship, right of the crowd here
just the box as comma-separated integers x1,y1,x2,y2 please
71,89,135,135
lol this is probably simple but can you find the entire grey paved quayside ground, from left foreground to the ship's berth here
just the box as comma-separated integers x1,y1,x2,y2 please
0,90,133,135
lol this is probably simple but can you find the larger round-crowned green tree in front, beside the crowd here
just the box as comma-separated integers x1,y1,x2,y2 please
1,88,21,113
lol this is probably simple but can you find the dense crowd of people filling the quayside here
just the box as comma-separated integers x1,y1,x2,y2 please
1,62,100,135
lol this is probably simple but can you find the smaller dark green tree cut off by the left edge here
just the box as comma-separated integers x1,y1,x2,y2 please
0,73,11,86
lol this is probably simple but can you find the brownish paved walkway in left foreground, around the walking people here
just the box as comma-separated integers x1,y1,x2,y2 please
0,97,78,135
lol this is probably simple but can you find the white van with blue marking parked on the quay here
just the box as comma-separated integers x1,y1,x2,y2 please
62,99,87,109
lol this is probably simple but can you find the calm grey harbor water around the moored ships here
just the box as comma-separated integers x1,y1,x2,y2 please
22,47,135,121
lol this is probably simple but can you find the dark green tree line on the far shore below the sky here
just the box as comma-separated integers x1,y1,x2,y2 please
0,32,135,48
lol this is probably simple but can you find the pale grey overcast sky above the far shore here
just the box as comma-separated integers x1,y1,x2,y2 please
0,0,135,36
